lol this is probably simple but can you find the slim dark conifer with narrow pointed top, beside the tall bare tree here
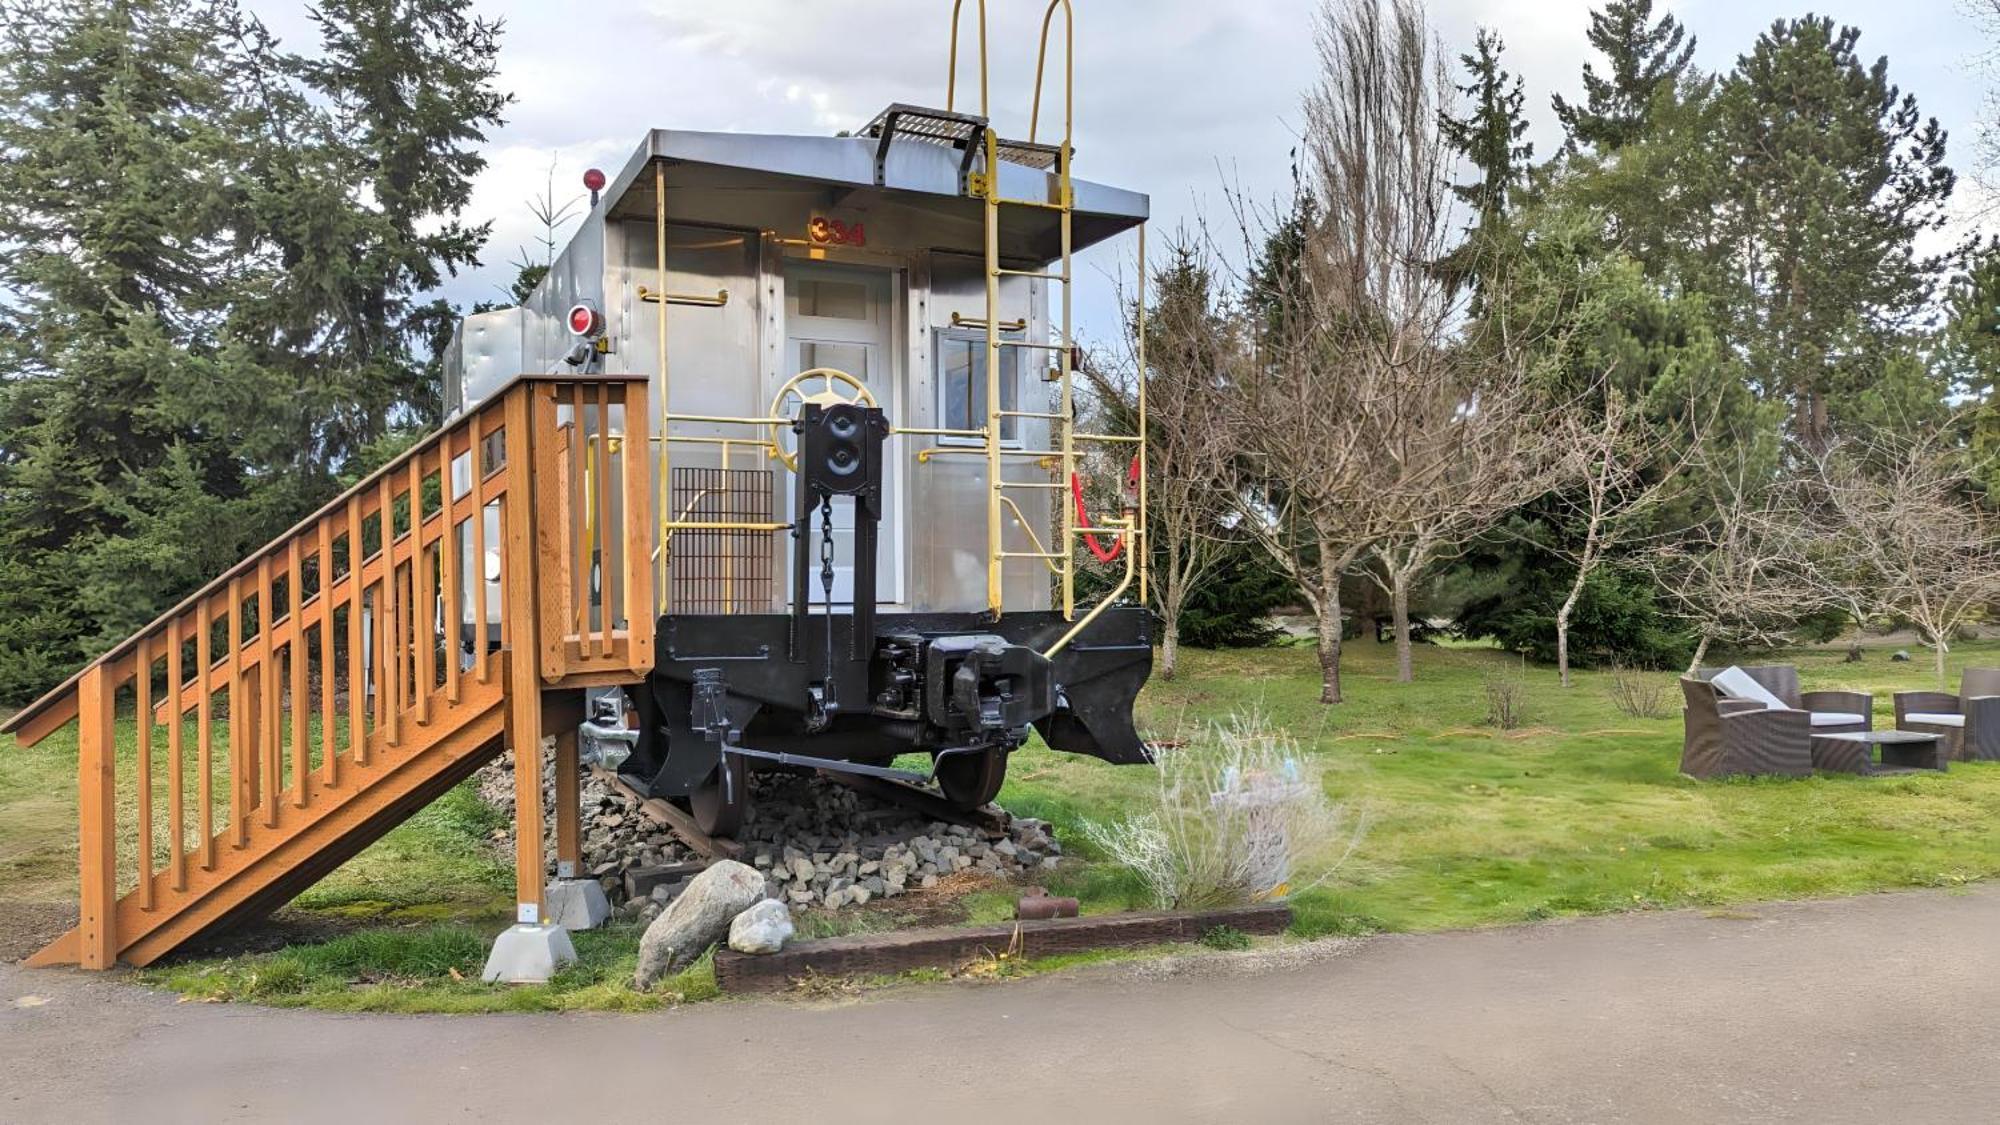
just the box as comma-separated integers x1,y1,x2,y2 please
1440,28,1534,316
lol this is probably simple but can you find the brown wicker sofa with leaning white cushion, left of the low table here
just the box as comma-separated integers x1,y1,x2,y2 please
1680,665,1874,777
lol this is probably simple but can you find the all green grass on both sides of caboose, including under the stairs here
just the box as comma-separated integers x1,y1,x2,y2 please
0,643,2000,1011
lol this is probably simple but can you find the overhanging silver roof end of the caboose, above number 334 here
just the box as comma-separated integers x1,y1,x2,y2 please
604,120,1148,262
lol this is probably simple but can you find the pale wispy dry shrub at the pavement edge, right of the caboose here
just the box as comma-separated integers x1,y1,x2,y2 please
1084,713,1364,911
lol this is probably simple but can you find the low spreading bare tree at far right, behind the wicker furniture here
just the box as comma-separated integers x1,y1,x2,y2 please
1814,426,2000,689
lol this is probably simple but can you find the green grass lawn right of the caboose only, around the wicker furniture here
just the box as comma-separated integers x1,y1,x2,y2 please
1002,643,2000,935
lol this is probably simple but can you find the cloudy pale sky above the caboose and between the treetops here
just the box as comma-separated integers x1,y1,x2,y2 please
252,0,1986,336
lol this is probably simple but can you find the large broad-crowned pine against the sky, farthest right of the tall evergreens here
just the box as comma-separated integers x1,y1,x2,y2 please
1720,16,1954,448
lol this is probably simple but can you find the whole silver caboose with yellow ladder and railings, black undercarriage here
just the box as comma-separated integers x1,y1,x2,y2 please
446,10,1150,835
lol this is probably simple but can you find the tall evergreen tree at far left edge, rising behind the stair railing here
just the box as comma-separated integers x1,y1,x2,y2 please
0,0,272,672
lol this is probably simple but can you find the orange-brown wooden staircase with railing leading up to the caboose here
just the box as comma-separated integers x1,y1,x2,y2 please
0,374,656,969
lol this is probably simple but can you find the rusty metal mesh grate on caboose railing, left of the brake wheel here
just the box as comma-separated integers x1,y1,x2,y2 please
668,468,776,613
